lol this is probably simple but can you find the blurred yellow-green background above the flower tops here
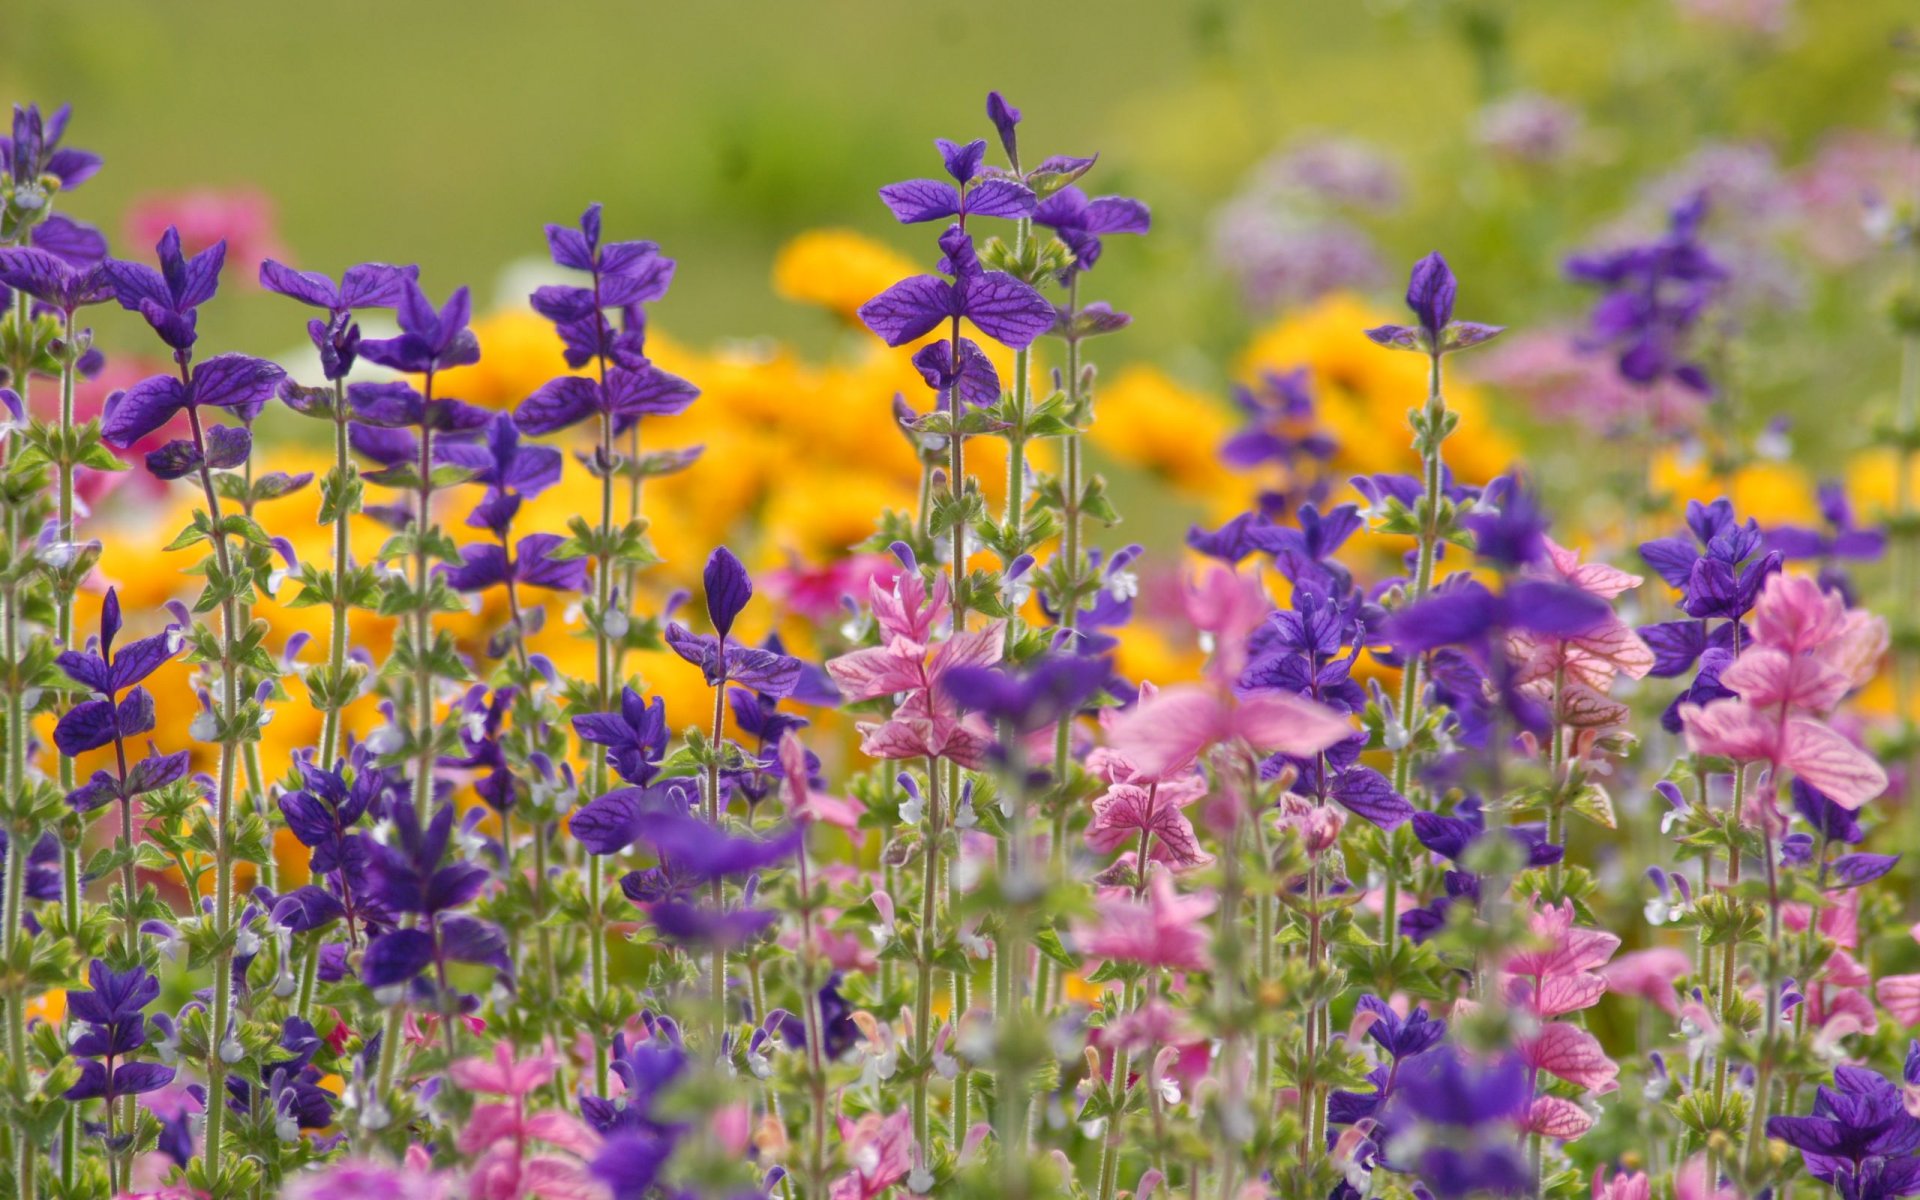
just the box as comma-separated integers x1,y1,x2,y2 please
0,0,1916,462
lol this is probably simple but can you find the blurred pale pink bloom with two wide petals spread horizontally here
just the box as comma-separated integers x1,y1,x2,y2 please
1112,684,1354,780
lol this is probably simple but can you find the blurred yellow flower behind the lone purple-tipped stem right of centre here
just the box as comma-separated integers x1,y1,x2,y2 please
1240,296,1517,482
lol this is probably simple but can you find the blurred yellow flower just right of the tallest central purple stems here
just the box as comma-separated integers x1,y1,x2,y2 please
1089,367,1238,495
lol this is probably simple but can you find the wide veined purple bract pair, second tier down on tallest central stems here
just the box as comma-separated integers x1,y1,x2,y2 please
860,225,1054,349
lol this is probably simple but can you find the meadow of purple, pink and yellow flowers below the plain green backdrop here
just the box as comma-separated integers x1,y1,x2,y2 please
0,0,1920,1200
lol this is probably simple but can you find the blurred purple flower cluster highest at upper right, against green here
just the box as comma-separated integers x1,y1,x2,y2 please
1567,192,1728,394
